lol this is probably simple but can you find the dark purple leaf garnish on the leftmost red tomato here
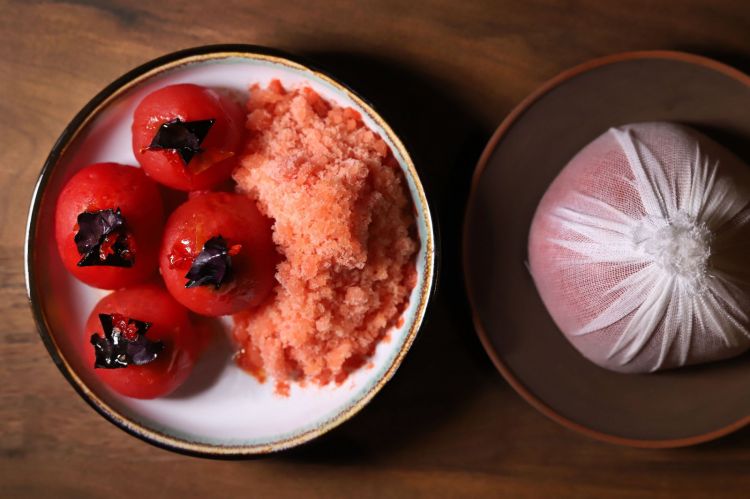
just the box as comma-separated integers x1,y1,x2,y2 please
73,208,135,267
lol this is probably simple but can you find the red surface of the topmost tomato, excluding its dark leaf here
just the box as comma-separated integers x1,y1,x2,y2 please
132,83,245,191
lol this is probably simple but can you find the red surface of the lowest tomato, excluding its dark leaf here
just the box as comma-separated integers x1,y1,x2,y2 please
82,284,205,399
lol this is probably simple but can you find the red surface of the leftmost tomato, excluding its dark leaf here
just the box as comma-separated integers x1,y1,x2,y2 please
55,163,164,289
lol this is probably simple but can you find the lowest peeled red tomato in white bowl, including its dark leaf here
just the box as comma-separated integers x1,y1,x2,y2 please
83,284,205,399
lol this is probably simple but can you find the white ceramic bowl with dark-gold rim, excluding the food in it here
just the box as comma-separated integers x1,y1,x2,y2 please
25,45,435,456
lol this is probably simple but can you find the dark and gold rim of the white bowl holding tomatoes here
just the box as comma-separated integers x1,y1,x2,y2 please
24,44,440,459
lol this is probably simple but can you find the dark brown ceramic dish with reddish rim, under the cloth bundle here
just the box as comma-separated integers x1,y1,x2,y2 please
464,51,750,447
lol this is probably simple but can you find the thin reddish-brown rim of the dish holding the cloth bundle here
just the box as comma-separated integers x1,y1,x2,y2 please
462,50,750,449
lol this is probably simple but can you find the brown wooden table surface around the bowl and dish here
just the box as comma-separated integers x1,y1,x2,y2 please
0,0,750,498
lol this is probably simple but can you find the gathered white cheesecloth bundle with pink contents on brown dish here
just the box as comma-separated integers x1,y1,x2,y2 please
529,123,750,372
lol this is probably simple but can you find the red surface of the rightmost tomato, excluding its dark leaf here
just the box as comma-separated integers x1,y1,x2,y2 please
159,192,278,316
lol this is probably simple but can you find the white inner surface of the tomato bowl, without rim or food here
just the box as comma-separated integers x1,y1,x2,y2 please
31,56,432,446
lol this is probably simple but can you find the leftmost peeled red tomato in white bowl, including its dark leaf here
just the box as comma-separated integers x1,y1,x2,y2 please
55,163,164,289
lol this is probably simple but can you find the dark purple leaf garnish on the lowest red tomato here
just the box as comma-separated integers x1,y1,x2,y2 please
91,314,164,369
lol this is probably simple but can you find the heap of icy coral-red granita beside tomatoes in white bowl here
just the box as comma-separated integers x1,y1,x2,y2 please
234,81,418,395
